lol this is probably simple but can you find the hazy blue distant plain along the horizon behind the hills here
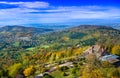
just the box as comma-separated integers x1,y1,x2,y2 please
23,23,120,30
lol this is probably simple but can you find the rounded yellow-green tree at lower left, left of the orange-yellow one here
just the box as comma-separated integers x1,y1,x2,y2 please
8,63,22,78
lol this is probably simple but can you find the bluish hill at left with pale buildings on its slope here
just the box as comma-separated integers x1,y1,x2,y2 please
0,25,54,49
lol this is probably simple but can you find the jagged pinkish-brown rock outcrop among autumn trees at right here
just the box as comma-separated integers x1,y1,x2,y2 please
83,45,108,58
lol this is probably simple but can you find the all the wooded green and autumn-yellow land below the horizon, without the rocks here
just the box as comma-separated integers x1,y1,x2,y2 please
0,25,120,78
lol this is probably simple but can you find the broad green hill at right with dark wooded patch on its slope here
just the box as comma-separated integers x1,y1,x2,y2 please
39,25,120,49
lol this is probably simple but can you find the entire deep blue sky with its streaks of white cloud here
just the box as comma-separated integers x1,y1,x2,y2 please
0,0,120,25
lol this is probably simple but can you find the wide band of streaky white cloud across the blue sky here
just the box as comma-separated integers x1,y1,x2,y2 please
0,2,120,24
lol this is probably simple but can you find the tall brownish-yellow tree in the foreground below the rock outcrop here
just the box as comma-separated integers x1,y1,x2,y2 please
82,55,104,78
